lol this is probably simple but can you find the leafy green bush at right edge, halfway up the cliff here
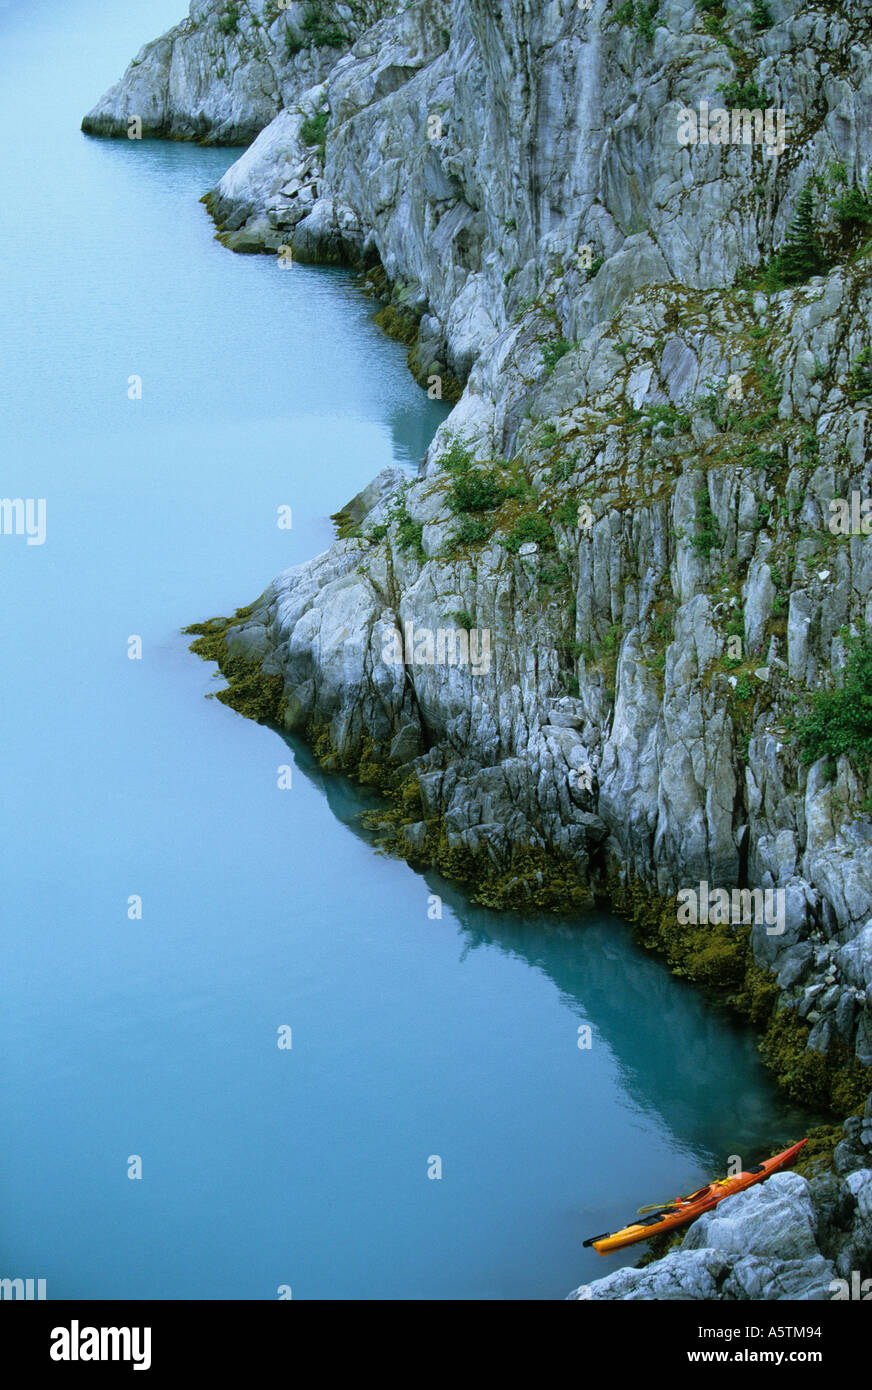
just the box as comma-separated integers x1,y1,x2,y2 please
794,631,872,767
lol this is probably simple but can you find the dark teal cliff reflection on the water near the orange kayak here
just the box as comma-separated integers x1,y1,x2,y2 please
288,738,821,1175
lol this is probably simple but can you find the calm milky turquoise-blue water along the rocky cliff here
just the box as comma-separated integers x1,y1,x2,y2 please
0,0,817,1300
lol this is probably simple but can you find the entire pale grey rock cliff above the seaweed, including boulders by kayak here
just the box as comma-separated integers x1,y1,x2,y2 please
86,0,872,1298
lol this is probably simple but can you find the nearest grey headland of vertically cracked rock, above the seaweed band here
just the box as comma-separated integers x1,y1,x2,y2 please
221,270,872,1065
